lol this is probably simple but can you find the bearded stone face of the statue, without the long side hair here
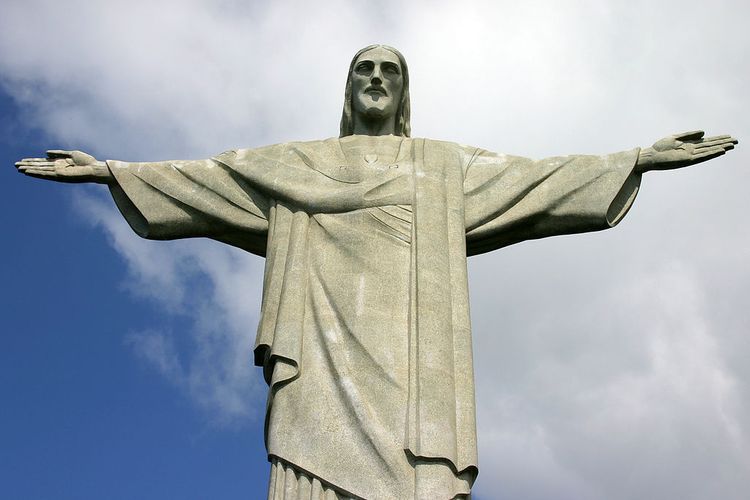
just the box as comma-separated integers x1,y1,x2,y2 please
352,47,404,123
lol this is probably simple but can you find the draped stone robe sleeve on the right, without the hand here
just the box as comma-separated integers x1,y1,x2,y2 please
464,149,641,255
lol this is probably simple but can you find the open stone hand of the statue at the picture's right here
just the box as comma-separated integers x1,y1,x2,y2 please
636,130,737,173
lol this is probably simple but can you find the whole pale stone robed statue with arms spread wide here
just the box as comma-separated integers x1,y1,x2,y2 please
16,45,737,499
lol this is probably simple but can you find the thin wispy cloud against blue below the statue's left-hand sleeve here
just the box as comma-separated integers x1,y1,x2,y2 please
70,190,265,425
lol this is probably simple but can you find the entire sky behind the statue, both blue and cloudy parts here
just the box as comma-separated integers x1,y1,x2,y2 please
0,0,750,500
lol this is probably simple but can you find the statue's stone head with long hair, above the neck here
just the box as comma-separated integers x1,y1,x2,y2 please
339,45,411,137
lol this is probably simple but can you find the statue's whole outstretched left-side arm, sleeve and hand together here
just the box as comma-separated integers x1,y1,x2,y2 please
16,150,269,255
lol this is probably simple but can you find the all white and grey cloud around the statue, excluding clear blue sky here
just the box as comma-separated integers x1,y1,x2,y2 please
0,1,750,500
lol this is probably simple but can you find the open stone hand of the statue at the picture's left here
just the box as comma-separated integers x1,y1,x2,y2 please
16,149,114,184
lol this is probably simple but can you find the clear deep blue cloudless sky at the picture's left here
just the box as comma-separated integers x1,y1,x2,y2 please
0,94,267,499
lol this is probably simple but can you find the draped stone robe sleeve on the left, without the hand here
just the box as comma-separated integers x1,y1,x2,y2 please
107,151,269,256
